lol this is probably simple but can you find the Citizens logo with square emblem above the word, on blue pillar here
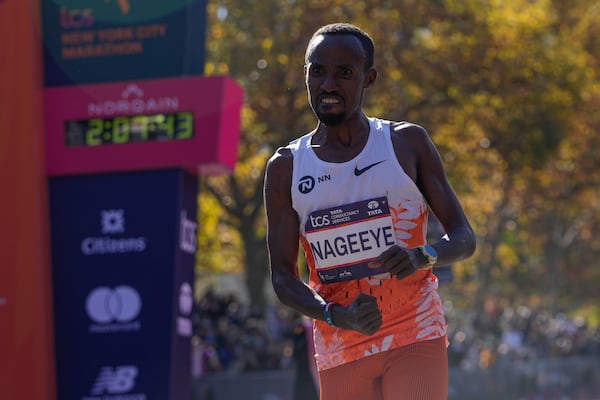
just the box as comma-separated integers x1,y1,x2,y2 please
81,209,147,256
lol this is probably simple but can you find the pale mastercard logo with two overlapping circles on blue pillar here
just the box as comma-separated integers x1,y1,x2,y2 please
85,285,142,333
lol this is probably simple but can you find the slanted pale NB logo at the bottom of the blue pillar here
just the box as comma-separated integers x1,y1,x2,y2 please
82,365,147,400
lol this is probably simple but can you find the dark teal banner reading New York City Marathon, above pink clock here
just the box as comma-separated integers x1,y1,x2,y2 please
41,0,207,86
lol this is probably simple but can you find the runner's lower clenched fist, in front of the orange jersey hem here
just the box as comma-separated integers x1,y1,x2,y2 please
332,293,382,335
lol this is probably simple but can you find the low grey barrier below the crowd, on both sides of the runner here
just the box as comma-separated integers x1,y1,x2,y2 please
194,356,600,400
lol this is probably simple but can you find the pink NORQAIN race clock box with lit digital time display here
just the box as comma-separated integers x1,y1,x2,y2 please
44,76,244,176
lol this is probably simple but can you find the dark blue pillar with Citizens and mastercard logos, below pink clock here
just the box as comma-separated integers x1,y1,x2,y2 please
49,169,197,400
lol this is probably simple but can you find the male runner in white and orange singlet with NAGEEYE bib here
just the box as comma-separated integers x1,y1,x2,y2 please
264,23,475,400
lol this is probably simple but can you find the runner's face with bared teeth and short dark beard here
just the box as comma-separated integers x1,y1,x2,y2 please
304,35,374,125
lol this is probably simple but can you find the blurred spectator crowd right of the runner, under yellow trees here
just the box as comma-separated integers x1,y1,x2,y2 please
446,300,600,370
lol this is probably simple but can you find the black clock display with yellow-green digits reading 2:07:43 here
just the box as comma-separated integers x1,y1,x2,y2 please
65,112,194,147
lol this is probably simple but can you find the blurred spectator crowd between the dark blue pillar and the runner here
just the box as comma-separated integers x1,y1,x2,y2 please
192,290,305,378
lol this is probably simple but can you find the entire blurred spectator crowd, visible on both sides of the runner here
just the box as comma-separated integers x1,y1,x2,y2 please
193,290,600,378
